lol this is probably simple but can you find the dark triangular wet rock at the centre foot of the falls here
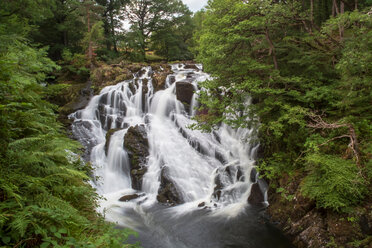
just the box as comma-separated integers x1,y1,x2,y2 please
156,166,184,206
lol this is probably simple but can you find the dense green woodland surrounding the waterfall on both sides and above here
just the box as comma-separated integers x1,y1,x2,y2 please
0,0,372,247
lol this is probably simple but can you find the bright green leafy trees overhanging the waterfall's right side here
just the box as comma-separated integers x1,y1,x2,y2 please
193,0,372,211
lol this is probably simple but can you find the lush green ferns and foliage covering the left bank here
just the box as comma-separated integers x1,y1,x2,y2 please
0,4,138,247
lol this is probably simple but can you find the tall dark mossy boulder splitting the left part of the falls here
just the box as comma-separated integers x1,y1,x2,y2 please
124,125,149,190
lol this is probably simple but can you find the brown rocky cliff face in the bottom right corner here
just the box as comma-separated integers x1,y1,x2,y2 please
267,174,372,248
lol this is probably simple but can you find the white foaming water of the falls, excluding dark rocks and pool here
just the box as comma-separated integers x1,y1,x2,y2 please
70,64,270,247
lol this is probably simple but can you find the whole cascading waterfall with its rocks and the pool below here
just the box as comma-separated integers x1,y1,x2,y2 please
70,64,289,248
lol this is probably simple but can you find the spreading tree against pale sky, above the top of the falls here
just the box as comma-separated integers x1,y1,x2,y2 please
127,0,191,59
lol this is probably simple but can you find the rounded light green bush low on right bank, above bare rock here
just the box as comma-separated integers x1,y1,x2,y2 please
301,153,367,211
